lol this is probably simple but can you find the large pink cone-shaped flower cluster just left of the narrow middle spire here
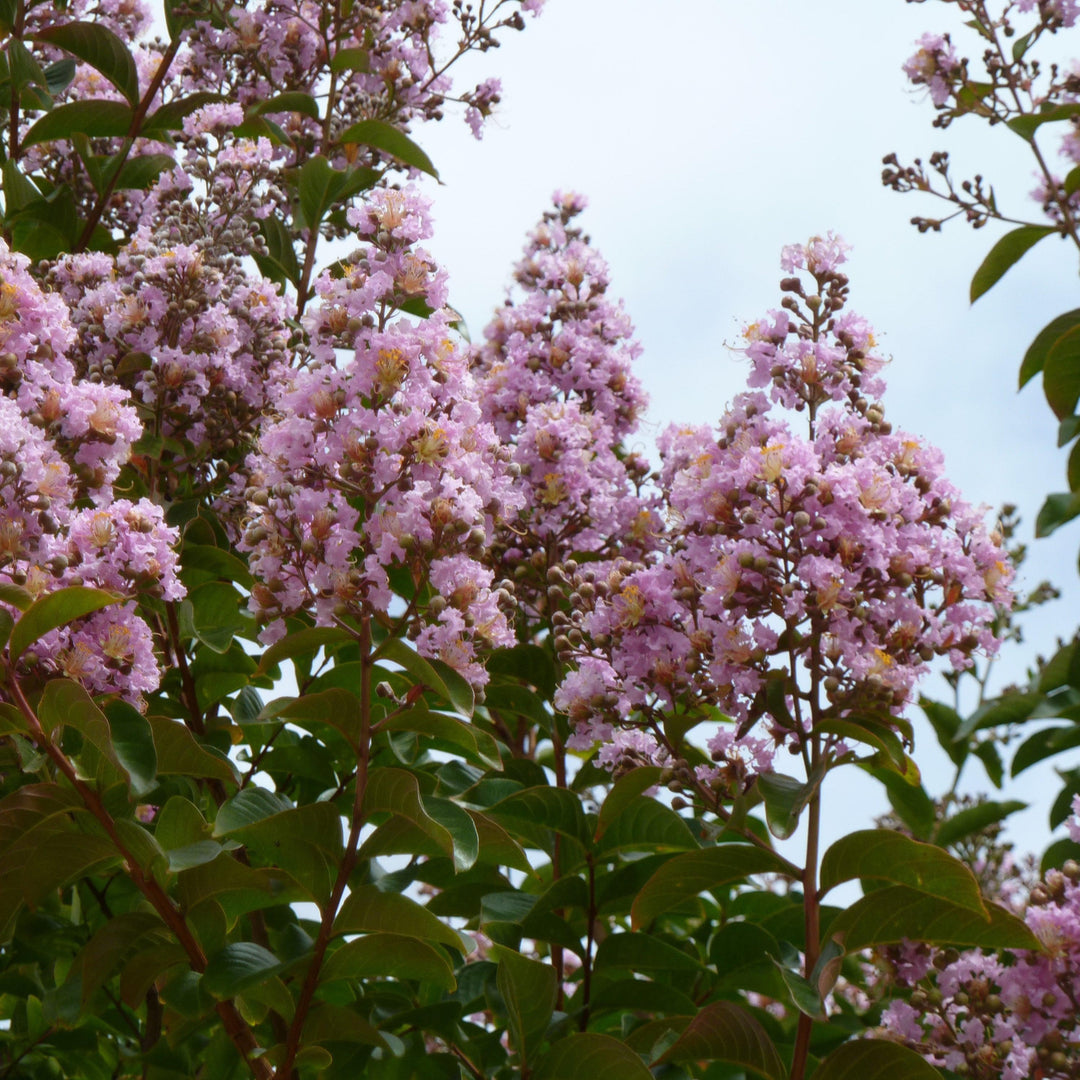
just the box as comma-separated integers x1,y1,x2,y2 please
240,189,522,685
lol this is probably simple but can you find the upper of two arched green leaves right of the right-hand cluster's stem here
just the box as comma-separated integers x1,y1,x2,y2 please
821,828,986,915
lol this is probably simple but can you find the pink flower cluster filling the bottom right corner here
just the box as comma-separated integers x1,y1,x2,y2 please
881,802,1080,1080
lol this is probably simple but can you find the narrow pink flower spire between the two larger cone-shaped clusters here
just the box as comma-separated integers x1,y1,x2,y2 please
476,193,661,612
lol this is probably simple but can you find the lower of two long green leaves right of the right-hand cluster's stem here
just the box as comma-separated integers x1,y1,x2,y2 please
824,885,1040,953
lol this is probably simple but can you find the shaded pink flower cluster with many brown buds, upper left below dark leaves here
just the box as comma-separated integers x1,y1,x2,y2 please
46,144,293,481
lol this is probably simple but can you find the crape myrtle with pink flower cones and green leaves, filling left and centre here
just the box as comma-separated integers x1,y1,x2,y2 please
0,0,1054,1080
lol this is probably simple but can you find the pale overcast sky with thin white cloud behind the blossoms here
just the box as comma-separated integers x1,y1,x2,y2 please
416,0,1080,847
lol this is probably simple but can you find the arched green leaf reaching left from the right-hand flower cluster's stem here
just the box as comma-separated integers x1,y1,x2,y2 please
631,843,799,930
